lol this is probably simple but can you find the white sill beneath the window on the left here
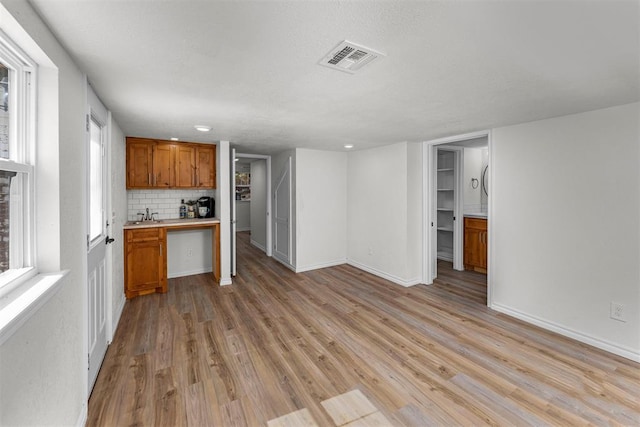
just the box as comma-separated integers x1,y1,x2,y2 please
0,270,69,345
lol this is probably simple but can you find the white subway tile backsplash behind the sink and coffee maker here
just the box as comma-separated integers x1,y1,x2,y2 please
127,189,218,221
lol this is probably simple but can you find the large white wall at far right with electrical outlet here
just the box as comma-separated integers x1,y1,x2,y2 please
489,103,640,361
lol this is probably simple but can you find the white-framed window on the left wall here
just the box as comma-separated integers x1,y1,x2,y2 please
0,28,35,294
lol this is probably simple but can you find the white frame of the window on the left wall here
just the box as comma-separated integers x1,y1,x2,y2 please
0,30,37,297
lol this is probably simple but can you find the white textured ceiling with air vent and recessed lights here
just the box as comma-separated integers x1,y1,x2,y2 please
31,0,640,154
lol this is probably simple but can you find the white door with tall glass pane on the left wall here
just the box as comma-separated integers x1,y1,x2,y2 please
86,85,109,391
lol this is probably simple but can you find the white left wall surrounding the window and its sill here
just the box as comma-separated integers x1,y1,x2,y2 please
0,0,94,425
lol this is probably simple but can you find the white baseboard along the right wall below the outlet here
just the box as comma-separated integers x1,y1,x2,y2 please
491,303,640,362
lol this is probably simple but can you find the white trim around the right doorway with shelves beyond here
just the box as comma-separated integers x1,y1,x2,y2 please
422,130,495,307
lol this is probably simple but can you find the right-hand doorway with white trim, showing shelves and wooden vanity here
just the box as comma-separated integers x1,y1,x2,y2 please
423,131,491,305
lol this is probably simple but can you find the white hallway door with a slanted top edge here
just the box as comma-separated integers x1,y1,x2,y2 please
273,157,291,265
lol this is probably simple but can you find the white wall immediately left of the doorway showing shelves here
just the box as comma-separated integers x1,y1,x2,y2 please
347,143,422,286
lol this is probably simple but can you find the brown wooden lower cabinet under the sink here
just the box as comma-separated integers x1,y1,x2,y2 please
124,227,167,298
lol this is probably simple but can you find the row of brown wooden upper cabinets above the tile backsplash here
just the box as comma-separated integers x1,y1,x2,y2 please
127,137,216,189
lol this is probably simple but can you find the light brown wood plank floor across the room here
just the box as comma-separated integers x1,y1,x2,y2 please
87,233,640,426
